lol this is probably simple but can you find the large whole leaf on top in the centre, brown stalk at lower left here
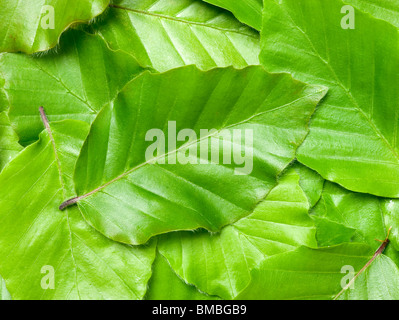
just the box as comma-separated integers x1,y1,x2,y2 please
65,66,326,244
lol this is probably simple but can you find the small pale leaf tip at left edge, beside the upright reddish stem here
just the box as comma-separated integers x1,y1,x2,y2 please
0,111,22,171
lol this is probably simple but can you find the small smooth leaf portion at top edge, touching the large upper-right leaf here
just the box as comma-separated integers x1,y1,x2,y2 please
204,0,263,30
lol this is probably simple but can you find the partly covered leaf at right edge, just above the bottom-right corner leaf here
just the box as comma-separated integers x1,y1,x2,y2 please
311,182,399,264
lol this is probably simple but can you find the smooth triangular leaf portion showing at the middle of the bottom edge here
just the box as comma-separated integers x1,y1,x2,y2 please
145,253,219,300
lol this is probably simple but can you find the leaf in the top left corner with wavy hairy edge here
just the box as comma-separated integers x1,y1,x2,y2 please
0,0,109,54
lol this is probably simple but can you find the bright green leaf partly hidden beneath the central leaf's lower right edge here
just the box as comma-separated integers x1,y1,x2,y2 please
159,169,317,299
